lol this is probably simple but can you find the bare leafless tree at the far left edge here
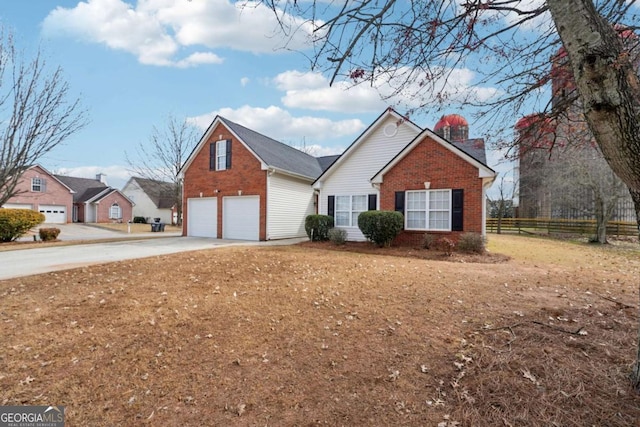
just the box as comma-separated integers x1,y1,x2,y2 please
0,27,87,206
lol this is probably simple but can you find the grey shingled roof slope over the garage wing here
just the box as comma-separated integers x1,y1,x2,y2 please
219,117,323,179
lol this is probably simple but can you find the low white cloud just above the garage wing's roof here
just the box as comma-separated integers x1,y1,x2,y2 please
189,105,366,149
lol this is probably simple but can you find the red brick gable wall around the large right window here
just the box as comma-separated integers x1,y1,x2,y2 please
380,138,484,245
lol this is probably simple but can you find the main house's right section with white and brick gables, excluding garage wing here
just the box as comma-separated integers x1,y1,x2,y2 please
313,109,496,244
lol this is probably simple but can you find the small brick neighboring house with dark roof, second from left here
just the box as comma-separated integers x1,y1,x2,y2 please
54,174,133,223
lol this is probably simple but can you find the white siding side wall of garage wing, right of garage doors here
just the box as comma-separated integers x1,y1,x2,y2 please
267,173,315,240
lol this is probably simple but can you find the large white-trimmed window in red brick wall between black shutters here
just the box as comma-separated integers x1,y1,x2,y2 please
405,190,451,231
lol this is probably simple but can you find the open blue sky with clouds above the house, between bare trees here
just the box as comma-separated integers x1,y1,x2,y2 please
0,0,510,188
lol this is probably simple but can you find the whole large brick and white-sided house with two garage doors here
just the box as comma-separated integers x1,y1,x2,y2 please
181,109,496,244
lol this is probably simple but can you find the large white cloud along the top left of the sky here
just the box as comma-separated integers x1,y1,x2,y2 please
43,0,310,67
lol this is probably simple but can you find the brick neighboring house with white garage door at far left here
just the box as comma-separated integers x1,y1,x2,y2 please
2,165,74,224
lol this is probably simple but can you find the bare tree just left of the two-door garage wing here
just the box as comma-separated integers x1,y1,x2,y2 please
125,115,199,224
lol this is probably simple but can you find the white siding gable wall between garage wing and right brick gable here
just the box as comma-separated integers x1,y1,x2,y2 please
319,117,418,241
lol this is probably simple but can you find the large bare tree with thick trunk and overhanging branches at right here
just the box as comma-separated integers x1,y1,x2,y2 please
263,0,640,389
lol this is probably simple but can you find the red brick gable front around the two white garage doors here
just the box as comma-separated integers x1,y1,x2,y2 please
182,124,267,240
